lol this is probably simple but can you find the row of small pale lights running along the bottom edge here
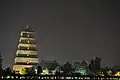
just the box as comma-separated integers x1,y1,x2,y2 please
1,76,120,80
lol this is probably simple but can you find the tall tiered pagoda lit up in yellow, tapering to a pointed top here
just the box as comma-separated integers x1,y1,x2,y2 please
13,25,39,73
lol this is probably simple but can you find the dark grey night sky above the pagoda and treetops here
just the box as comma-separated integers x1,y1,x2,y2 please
0,0,120,67
